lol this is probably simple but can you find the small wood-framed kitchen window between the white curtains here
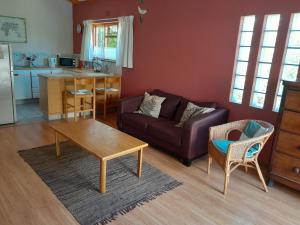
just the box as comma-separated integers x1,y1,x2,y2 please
94,23,118,60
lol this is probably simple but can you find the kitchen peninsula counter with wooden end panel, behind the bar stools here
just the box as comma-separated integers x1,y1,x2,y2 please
38,69,113,120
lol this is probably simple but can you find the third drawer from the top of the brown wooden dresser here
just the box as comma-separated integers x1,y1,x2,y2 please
276,131,300,159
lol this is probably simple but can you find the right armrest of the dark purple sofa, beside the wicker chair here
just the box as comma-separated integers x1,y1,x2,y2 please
182,108,229,159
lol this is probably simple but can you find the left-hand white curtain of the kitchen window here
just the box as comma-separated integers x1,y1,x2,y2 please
80,20,93,61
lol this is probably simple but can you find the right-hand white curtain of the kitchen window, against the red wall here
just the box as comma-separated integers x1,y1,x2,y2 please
116,16,134,72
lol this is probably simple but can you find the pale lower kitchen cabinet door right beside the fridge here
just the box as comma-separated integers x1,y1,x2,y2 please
14,70,32,100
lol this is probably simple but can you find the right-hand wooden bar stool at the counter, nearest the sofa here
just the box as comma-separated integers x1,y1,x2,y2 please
96,76,121,119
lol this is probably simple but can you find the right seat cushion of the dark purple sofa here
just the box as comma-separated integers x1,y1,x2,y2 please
147,118,183,147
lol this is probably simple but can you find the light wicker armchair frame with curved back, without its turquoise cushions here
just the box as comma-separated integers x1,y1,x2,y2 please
207,120,274,195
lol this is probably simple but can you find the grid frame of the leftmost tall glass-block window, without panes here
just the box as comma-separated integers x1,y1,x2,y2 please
229,15,256,104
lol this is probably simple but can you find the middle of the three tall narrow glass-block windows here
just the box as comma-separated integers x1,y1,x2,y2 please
250,14,280,109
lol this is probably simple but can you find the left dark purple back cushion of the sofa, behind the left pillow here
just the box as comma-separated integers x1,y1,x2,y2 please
151,89,182,119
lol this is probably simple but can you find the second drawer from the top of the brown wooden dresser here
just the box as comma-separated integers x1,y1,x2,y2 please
280,110,300,134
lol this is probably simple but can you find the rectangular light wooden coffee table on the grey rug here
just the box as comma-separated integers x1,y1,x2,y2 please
50,120,148,193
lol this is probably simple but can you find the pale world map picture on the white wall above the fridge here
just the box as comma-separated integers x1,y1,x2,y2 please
0,16,27,43
